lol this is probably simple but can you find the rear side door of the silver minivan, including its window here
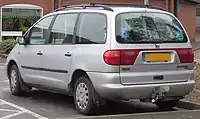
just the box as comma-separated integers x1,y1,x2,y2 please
40,13,78,89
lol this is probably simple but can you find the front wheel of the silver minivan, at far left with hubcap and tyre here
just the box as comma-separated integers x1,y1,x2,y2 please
9,65,23,96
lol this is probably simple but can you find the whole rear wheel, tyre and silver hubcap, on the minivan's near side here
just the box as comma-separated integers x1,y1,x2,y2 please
74,76,97,115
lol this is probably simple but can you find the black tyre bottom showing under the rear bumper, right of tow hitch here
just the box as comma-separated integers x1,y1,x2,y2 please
155,100,179,109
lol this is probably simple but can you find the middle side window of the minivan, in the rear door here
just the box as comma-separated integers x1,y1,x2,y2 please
49,13,78,44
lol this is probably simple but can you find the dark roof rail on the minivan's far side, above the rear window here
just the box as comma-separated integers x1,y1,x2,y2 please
90,3,168,11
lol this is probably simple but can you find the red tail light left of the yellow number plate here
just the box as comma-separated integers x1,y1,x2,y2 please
103,50,139,66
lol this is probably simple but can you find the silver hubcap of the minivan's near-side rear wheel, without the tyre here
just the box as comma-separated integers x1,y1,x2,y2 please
76,83,89,110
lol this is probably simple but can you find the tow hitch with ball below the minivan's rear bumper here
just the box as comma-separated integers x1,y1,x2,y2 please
151,86,169,103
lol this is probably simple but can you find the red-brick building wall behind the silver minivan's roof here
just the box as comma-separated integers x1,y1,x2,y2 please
0,0,196,39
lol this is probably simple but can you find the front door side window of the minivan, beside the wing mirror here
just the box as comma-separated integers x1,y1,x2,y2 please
29,16,54,45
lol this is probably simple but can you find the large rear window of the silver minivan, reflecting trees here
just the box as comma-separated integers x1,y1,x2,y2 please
116,13,188,44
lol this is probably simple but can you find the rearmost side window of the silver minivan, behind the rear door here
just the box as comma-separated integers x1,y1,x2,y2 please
76,13,107,44
